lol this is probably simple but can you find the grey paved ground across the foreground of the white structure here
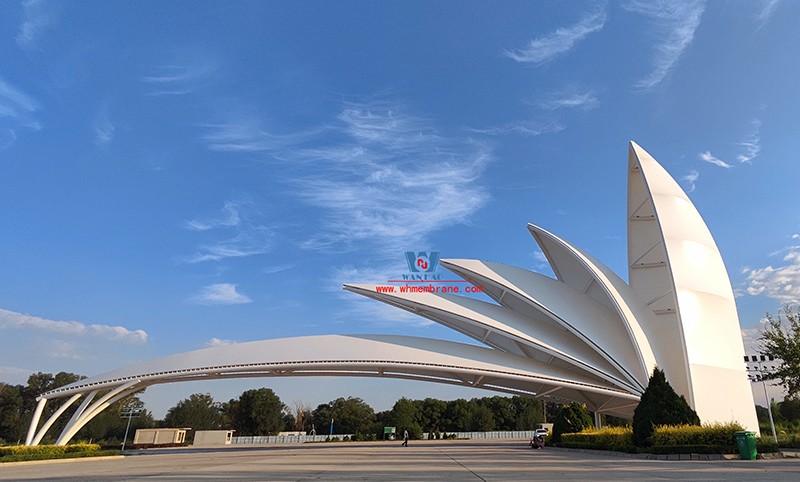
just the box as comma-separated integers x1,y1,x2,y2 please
0,440,800,482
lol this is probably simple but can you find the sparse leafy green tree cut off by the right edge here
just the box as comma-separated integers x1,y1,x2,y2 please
759,306,800,398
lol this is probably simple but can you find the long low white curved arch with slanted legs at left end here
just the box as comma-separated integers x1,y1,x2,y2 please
26,335,638,445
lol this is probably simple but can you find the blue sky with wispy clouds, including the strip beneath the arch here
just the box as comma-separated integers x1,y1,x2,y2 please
0,0,800,415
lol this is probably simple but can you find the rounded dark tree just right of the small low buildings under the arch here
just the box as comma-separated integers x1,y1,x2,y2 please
228,388,287,436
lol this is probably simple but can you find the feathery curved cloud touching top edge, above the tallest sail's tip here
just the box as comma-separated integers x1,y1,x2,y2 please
623,0,705,92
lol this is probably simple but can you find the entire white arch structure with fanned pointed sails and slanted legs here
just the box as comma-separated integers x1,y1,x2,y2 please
25,142,758,445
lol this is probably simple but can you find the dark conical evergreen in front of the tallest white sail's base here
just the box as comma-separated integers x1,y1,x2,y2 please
633,367,700,446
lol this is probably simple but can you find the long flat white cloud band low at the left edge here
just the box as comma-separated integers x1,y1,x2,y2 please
0,309,147,343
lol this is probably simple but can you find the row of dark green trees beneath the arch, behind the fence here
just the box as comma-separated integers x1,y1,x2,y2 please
159,388,552,438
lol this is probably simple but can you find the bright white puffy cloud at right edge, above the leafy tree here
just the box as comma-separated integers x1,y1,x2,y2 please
742,243,800,304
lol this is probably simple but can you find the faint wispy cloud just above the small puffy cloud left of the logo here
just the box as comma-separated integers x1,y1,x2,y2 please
182,199,274,263
